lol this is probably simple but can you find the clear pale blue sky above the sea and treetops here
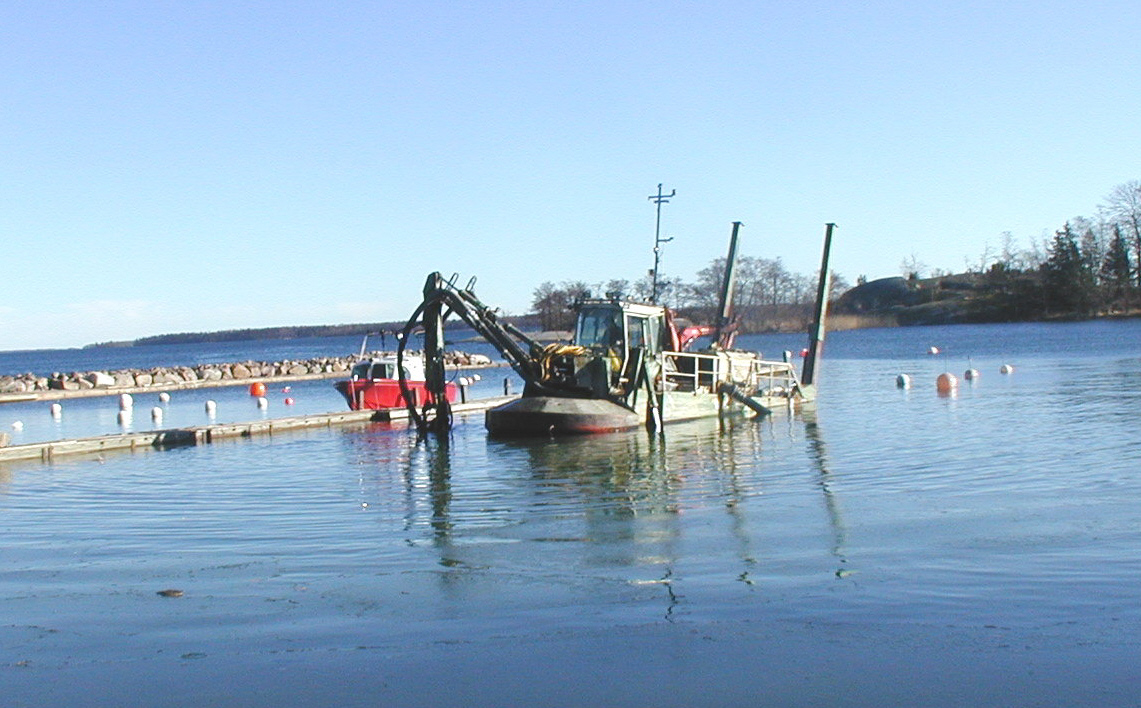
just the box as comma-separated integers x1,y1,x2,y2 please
0,0,1141,349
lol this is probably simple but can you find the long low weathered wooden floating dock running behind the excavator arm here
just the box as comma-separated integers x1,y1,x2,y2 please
0,396,516,463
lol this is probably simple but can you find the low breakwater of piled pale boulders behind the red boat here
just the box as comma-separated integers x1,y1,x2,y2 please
0,351,491,399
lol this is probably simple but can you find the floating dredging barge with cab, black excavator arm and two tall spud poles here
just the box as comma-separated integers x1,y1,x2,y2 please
397,222,835,437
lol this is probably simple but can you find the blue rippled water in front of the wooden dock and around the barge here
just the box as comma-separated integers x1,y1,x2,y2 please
0,323,1141,706
